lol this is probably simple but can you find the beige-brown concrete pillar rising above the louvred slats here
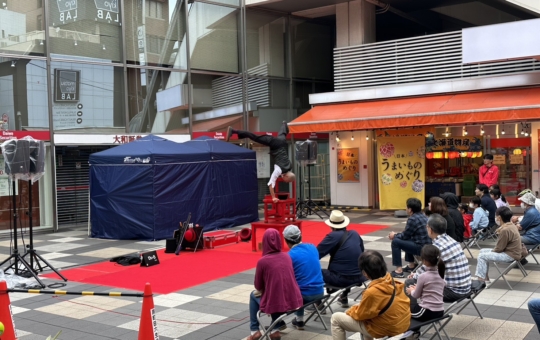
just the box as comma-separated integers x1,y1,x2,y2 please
336,0,375,47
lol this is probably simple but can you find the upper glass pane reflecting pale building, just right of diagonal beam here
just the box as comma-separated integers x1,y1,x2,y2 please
189,2,240,73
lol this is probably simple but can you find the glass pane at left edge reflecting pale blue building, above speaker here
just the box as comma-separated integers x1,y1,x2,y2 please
0,58,49,130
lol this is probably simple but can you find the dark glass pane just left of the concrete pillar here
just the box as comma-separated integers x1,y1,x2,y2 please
291,18,335,80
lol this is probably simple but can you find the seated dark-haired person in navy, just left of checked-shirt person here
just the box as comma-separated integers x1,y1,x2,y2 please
388,198,431,277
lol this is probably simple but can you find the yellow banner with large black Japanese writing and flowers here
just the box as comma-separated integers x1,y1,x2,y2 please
377,137,426,210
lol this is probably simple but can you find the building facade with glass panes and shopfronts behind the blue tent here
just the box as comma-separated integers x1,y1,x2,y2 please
4,0,540,229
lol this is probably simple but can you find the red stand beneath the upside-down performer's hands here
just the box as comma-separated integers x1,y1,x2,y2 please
251,178,302,251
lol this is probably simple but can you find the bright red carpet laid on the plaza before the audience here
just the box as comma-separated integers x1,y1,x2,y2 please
43,221,386,294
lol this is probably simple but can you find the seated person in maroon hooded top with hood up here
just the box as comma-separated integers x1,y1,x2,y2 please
247,229,302,340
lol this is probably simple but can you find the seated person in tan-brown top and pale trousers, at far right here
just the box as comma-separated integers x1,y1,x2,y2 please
476,207,522,283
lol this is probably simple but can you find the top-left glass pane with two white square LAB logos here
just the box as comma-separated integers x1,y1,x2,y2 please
47,0,122,62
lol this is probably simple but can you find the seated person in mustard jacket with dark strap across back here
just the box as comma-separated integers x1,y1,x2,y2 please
331,250,411,340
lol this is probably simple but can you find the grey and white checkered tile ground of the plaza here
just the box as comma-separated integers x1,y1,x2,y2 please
0,211,540,340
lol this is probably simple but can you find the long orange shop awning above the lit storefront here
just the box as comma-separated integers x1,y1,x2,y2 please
289,88,540,133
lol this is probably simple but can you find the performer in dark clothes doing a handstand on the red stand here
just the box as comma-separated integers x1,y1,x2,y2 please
226,122,296,203
